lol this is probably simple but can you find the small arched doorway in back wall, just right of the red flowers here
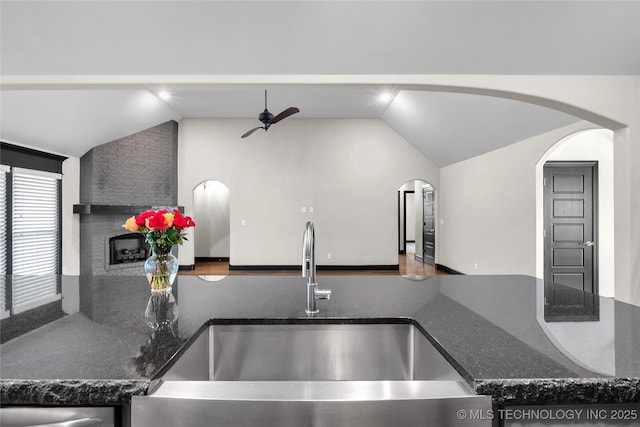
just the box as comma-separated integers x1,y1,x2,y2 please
193,180,231,263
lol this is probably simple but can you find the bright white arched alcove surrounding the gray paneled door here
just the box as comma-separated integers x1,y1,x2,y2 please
536,129,615,305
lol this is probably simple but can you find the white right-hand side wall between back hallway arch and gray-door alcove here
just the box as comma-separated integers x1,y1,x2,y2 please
438,122,593,276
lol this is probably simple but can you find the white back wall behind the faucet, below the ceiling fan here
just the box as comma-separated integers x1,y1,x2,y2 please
178,118,438,265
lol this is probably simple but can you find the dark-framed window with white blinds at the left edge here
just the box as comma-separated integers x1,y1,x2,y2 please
0,143,64,318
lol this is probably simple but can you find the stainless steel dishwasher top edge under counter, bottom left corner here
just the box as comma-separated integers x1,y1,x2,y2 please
0,406,115,427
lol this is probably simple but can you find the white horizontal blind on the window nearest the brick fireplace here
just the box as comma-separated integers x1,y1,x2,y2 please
11,168,61,313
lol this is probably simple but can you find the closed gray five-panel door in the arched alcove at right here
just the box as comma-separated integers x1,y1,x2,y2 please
544,162,598,320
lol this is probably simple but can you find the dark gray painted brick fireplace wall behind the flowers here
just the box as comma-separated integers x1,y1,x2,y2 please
80,121,178,276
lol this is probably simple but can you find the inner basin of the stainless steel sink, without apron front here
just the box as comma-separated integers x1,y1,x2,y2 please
162,323,462,381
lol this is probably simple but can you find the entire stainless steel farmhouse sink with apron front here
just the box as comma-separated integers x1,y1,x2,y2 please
132,319,491,427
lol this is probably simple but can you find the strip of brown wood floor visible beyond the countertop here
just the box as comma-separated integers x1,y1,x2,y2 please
178,254,447,276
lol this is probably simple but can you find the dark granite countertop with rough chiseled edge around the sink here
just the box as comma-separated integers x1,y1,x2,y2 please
0,275,640,405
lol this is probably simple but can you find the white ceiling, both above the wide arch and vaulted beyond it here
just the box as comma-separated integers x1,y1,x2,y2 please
0,0,640,166
